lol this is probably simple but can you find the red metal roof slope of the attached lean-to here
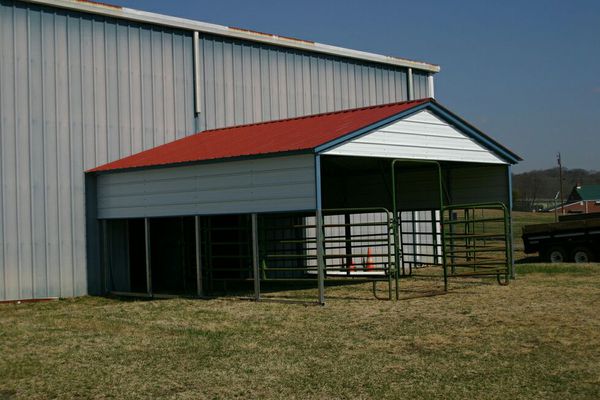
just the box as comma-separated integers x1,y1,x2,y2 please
88,99,433,172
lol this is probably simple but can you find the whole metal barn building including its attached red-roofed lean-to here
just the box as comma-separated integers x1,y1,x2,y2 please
0,0,519,302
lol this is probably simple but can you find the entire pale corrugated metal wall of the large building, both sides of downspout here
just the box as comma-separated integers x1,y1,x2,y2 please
0,0,428,299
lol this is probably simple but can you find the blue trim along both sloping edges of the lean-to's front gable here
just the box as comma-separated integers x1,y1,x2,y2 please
315,99,523,165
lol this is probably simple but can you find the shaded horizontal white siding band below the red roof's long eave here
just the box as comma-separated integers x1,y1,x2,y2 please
98,155,315,218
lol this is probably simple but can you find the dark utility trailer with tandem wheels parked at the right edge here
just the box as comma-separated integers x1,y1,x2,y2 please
522,213,600,263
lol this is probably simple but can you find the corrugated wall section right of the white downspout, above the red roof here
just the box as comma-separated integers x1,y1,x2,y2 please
200,36,428,129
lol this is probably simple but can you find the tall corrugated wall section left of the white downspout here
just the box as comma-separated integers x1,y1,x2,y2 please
0,0,195,300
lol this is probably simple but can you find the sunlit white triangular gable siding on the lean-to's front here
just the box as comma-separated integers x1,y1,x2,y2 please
323,110,506,164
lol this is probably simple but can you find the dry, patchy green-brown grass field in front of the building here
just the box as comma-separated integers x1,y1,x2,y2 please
0,211,600,399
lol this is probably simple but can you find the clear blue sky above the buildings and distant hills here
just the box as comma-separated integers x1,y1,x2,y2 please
109,0,600,172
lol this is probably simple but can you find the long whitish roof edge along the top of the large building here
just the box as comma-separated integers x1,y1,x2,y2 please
21,0,440,73
